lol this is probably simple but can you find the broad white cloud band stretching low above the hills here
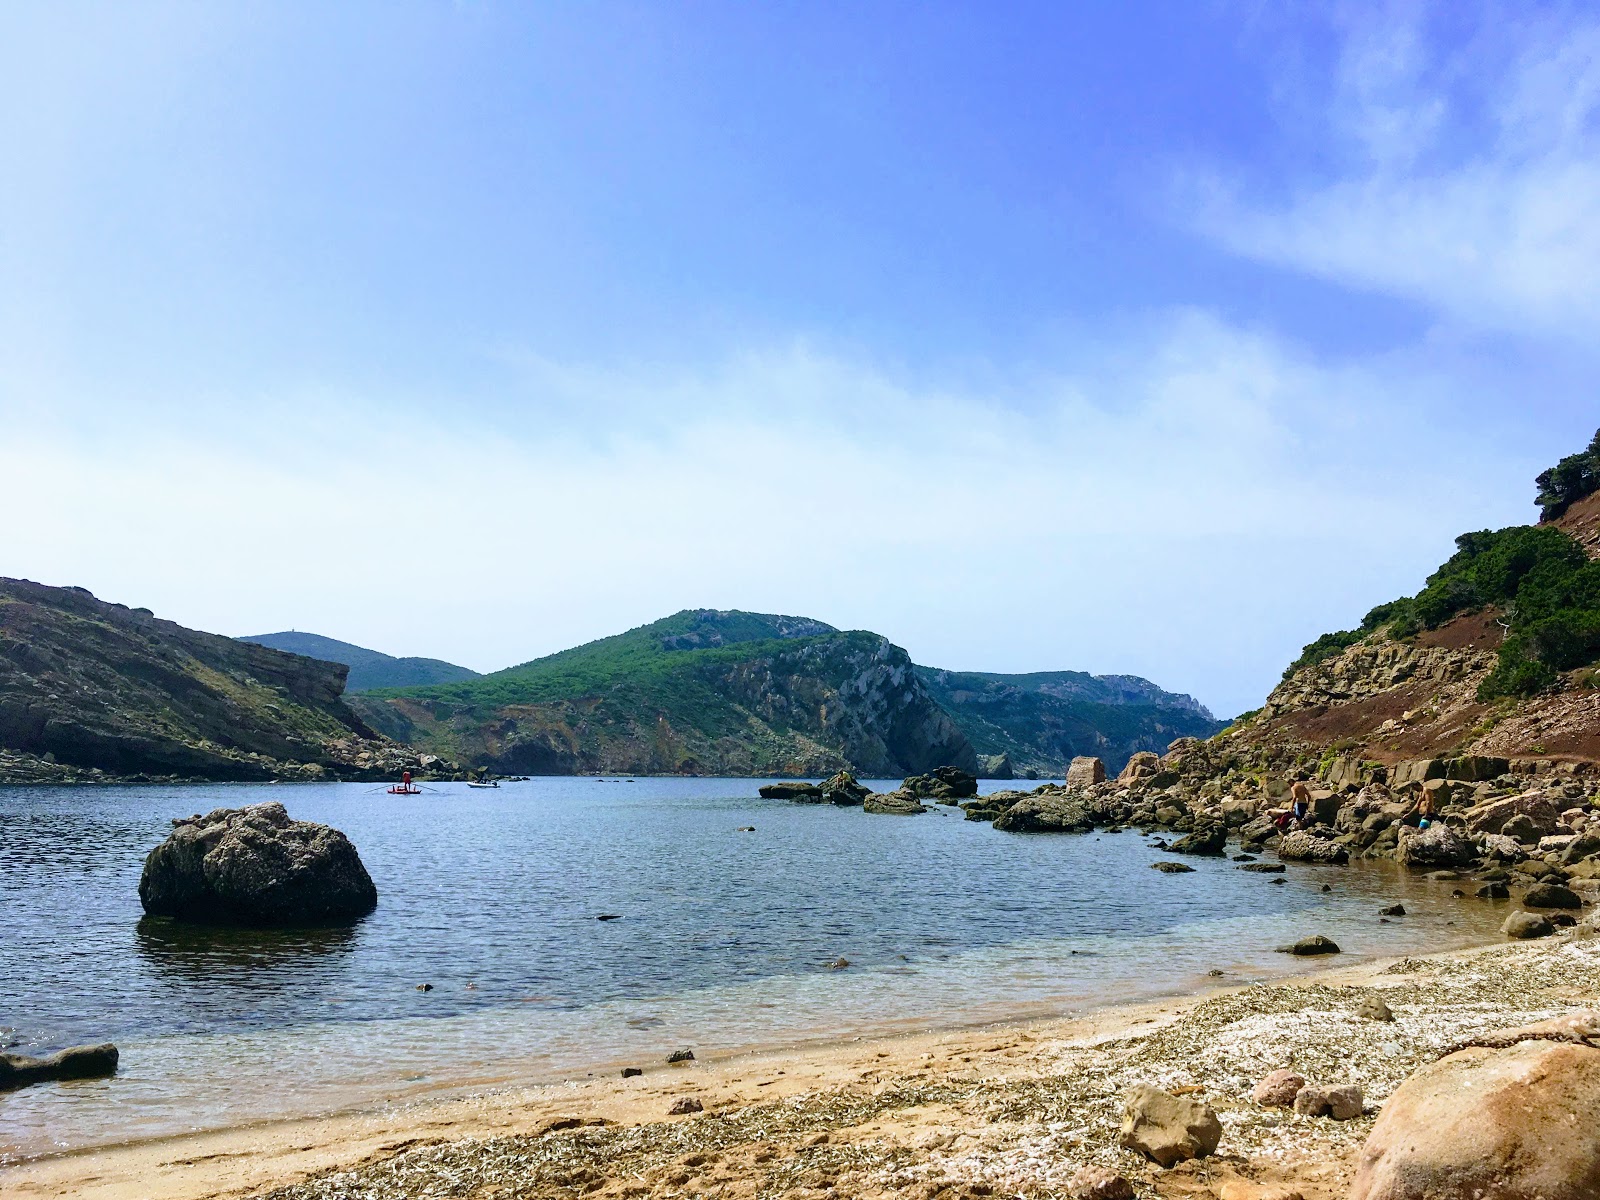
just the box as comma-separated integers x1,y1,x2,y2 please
0,314,1536,712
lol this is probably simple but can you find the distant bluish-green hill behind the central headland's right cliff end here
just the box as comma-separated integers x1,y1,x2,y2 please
917,667,1222,776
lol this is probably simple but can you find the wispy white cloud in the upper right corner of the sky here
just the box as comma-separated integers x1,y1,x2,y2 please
1192,11,1600,342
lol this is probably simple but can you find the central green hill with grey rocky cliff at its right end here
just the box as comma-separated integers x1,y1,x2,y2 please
352,610,976,776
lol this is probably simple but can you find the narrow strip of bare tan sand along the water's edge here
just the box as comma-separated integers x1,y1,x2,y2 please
0,936,1574,1200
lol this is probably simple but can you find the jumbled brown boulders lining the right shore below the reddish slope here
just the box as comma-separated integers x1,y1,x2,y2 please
793,731,1600,938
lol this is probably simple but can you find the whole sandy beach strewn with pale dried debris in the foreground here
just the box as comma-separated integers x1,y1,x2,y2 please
0,930,1600,1200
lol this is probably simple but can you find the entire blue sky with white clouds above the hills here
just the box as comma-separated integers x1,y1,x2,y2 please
0,3,1600,714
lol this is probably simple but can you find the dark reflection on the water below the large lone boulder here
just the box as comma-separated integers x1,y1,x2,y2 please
134,917,360,990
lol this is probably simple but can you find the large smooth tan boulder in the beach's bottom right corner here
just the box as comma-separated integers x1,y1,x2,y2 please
1350,1013,1600,1200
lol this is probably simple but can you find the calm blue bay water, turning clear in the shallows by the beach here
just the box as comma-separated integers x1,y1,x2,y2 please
0,778,1504,1158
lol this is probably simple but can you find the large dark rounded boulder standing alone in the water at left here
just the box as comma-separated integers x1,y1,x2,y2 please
139,803,378,925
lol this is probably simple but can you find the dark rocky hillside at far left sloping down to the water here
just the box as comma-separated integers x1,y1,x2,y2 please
0,579,413,779
